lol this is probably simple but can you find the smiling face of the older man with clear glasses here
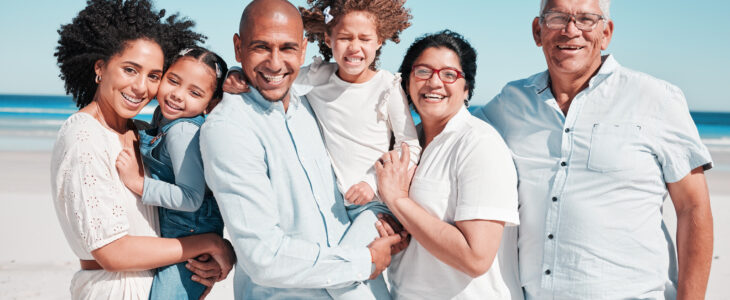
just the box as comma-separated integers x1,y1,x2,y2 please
532,0,613,76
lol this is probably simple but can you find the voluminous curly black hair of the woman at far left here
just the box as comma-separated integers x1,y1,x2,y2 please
53,0,206,108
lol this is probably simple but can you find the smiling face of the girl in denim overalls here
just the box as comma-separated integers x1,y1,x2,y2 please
157,57,216,120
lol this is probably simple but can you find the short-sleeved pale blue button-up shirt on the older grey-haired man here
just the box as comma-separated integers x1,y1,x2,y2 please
475,56,712,299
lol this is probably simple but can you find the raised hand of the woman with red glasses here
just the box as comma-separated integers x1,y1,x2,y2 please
375,143,416,205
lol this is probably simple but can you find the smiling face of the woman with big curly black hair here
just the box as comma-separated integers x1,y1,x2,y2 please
94,39,164,119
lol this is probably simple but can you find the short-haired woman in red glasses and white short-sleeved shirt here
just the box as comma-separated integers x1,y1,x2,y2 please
375,30,523,299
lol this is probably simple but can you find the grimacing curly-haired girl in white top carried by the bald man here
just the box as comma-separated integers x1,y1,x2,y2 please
295,0,420,209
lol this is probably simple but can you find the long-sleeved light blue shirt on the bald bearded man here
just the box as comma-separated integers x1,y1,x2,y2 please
200,88,371,299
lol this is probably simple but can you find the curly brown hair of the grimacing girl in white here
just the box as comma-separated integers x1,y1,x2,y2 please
299,0,413,70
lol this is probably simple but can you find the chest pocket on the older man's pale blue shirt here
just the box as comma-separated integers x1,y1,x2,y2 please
588,122,641,172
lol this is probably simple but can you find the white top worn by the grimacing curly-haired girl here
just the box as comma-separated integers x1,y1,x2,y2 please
296,58,421,198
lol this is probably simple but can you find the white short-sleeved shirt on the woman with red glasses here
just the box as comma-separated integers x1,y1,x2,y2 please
389,108,523,299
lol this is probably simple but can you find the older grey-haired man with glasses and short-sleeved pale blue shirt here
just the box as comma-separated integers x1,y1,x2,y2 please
475,0,713,299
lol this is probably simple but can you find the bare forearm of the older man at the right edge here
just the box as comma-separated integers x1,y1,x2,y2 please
667,167,713,299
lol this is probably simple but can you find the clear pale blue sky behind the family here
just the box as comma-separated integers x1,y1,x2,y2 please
0,0,730,111
